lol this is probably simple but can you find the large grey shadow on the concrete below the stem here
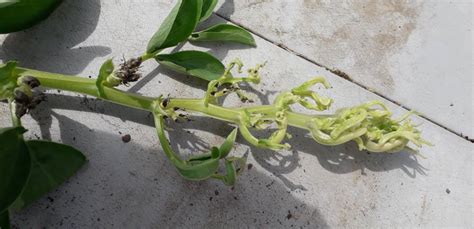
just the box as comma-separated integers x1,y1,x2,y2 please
13,94,328,228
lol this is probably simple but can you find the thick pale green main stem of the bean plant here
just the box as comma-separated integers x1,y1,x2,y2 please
16,68,318,129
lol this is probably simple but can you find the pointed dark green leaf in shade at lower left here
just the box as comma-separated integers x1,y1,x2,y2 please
12,141,86,210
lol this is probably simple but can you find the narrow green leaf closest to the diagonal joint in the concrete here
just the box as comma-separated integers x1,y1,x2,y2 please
189,24,256,47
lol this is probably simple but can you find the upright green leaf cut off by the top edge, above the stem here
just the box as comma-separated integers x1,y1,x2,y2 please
147,0,202,53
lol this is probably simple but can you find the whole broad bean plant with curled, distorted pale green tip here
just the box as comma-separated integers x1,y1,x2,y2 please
0,0,429,226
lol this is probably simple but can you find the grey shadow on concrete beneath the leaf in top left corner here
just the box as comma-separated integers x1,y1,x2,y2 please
0,0,111,75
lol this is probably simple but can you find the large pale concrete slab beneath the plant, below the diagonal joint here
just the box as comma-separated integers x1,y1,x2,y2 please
0,0,474,228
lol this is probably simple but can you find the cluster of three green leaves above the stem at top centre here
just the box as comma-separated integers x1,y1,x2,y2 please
146,0,255,81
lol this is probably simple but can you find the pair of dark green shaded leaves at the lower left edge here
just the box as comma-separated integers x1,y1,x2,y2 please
0,127,86,226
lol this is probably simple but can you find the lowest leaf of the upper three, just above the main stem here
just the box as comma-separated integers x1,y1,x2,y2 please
155,51,225,81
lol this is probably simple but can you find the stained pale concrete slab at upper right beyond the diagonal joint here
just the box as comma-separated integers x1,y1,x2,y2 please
218,0,474,136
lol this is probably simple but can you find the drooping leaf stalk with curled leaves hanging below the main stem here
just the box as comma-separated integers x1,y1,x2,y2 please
155,114,244,185
